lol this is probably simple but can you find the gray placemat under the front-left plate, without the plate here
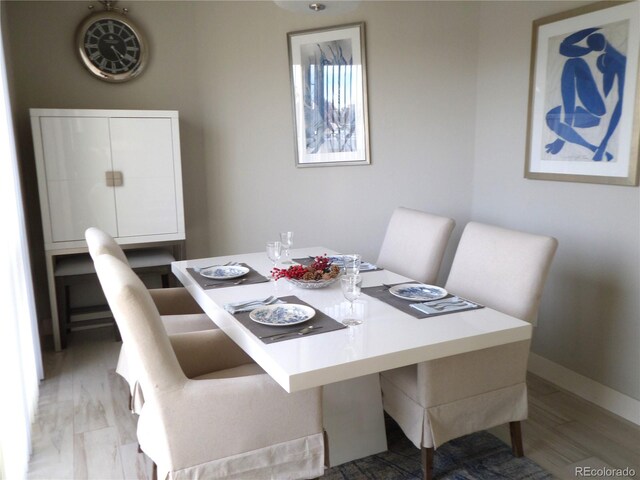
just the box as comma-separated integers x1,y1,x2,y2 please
234,295,347,343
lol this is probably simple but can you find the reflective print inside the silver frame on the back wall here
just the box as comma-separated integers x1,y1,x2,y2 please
301,39,360,154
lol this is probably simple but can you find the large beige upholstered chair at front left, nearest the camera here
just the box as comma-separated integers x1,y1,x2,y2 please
95,255,324,479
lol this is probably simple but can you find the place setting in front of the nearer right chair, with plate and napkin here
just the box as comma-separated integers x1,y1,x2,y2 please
362,282,484,318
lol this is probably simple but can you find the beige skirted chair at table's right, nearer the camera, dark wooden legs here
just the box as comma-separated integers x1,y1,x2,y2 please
380,222,557,479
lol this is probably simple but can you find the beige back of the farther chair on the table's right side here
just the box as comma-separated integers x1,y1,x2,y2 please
377,207,455,284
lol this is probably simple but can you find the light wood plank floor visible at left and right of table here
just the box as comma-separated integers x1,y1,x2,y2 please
29,328,640,480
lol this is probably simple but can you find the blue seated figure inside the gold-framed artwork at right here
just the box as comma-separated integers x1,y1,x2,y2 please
545,28,626,161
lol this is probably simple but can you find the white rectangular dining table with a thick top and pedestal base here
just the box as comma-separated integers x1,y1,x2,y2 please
172,247,532,466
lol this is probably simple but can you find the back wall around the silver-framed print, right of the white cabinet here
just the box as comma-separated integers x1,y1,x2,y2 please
195,2,478,259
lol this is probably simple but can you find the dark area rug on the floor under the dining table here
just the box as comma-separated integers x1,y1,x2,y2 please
322,415,553,480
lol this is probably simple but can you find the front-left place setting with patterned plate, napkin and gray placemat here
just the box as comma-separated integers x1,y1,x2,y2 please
224,295,346,344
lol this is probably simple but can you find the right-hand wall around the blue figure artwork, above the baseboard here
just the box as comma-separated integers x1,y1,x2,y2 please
472,2,640,400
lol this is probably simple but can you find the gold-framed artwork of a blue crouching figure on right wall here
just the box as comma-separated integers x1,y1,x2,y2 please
525,2,640,185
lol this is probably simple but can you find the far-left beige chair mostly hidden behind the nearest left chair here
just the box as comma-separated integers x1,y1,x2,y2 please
85,227,216,413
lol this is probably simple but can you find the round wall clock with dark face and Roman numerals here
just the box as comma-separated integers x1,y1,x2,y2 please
76,1,149,82
